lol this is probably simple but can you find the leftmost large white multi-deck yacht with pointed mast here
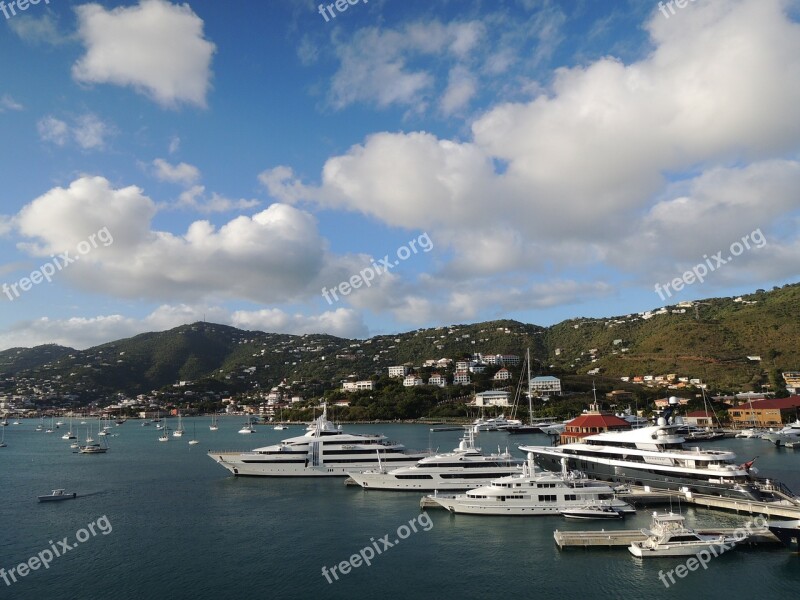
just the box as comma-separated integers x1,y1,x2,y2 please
208,406,427,477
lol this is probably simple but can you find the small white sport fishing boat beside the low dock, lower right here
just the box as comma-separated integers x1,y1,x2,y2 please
628,512,742,558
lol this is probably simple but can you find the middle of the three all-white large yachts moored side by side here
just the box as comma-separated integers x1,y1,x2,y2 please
348,428,523,492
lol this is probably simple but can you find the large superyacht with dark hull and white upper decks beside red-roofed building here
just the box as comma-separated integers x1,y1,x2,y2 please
520,400,774,500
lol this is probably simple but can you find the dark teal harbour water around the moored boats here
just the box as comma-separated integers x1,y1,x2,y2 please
0,418,800,600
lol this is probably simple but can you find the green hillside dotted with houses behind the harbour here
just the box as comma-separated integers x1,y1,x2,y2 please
0,284,800,395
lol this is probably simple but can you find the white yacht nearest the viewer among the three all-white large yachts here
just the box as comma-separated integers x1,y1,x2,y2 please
427,455,636,516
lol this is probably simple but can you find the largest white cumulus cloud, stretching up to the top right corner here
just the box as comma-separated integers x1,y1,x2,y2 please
268,0,800,296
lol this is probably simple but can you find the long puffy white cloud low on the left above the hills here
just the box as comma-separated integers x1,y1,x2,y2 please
8,177,356,304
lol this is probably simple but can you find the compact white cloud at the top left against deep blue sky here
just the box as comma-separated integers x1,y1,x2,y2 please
72,0,216,107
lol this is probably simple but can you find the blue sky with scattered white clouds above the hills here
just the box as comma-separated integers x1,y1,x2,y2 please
0,0,800,349
